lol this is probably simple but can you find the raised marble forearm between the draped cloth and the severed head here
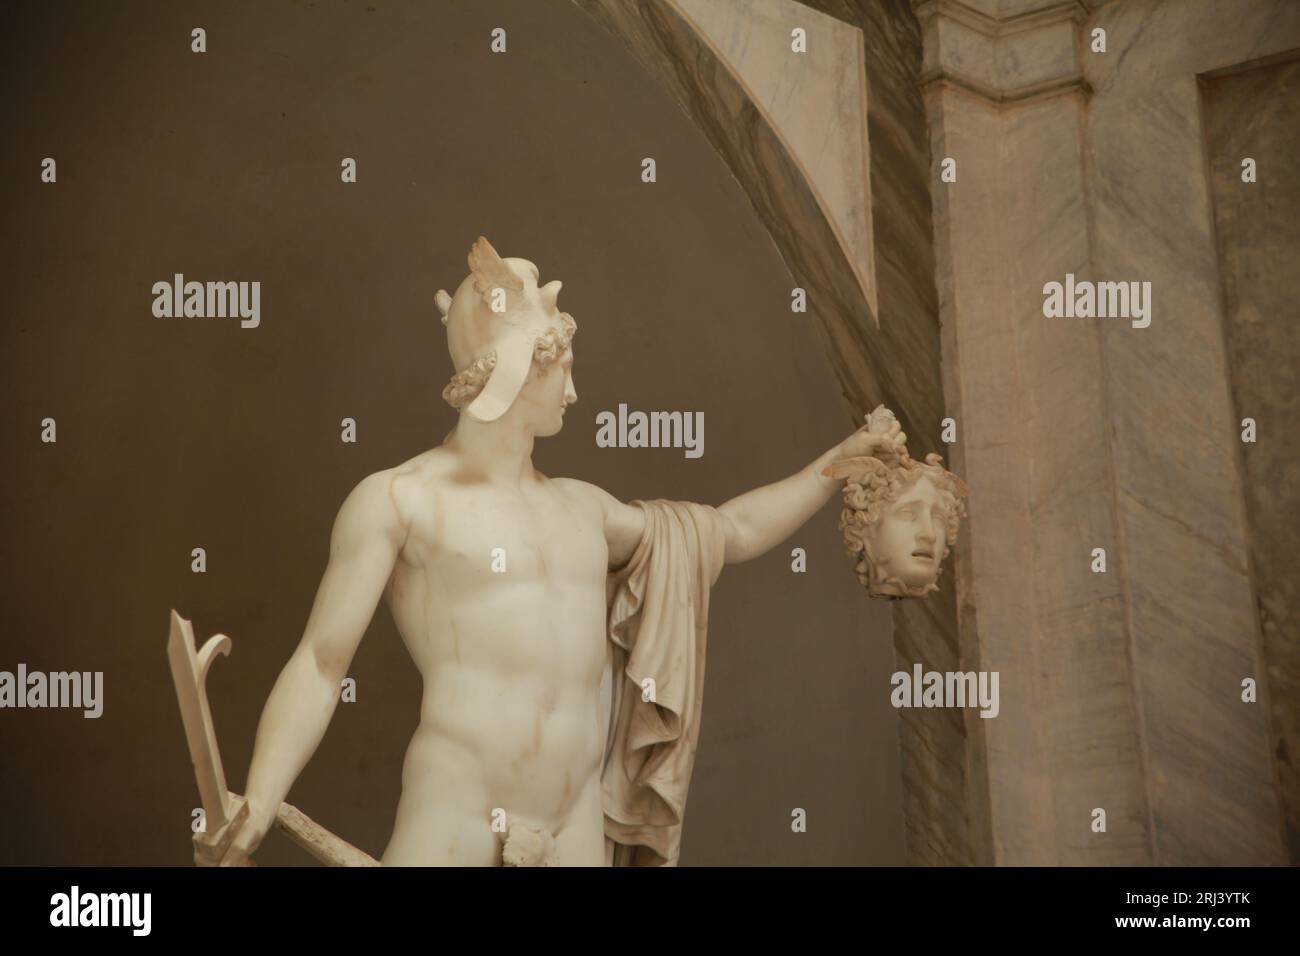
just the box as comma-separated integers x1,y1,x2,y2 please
718,445,840,564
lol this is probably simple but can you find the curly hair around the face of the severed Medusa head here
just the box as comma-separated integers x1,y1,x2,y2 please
840,445,969,597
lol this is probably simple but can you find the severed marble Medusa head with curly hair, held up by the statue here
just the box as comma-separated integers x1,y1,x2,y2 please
827,406,967,598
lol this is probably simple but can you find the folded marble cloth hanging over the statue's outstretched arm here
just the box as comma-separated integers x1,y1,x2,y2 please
601,501,725,866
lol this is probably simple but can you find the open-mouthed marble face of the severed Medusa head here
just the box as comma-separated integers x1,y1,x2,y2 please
868,475,948,589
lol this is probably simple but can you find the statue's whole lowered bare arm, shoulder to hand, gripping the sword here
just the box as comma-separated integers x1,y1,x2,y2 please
222,472,404,865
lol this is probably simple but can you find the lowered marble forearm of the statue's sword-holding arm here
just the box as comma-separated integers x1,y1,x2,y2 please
247,649,339,818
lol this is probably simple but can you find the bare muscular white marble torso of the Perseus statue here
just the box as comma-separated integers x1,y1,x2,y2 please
384,447,608,865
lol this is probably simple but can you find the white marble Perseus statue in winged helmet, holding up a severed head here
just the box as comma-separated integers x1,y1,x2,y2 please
173,238,967,865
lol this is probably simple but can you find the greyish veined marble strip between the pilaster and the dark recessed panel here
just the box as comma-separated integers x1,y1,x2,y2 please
1084,0,1300,865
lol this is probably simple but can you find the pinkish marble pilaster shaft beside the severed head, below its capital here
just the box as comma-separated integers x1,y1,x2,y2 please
931,87,1149,865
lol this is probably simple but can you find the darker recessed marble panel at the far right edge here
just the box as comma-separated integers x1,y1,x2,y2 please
1203,51,1300,865
